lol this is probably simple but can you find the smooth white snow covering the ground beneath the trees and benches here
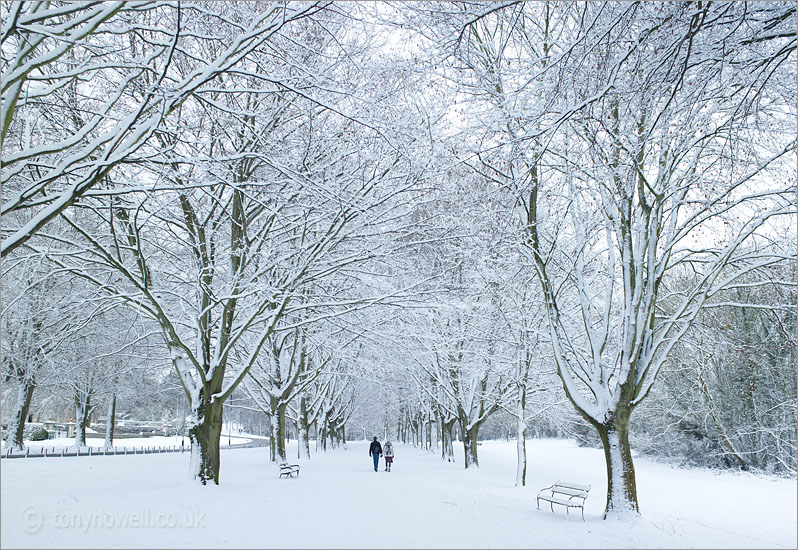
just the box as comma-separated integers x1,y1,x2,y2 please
1,440,798,548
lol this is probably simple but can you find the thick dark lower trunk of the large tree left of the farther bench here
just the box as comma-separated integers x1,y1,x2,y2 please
188,389,223,485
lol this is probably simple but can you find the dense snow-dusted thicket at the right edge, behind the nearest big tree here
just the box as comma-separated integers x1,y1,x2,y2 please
633,256,798,474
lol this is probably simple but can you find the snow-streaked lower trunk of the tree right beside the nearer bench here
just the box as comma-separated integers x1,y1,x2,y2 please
596,411,640,519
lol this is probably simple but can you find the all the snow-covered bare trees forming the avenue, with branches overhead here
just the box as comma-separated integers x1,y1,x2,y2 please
1,1,798,517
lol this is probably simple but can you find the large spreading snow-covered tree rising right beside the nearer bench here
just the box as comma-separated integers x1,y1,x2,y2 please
422,3,796,516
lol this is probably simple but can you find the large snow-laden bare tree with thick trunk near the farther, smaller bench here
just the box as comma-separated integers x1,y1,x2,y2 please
18,8,422,483
